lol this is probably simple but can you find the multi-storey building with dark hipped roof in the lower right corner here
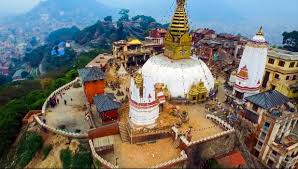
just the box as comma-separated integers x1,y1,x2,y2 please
242,90,298,169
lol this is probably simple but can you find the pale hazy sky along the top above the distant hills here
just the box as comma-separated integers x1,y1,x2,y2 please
0,0,298,14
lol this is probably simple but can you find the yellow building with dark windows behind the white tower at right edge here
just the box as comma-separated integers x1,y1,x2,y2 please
262,48,298,99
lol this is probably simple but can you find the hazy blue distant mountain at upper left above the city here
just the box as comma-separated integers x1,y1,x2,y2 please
8,0,113,27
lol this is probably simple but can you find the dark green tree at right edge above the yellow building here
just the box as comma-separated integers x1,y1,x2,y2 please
282,31,298,52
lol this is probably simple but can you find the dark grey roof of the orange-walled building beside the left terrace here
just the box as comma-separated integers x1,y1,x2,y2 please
78,67,105,83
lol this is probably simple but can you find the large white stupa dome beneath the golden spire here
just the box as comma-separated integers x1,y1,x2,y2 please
141,54,214,98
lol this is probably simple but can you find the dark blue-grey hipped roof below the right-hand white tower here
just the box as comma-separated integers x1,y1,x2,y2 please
245,90,289,110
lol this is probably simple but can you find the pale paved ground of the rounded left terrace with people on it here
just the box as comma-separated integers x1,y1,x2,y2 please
46,87,89,132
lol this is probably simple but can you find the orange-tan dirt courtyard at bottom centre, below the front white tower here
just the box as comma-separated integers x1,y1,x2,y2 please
101,135,180,168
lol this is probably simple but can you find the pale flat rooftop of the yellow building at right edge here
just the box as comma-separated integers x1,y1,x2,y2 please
268,48,298,61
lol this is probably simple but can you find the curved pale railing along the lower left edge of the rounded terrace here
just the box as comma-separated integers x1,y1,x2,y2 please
34,115,88,139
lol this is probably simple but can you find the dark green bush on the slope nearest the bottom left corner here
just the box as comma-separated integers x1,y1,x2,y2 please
17,132,43,168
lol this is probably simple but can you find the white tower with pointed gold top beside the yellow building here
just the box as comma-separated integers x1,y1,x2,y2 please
233,27,268,99
